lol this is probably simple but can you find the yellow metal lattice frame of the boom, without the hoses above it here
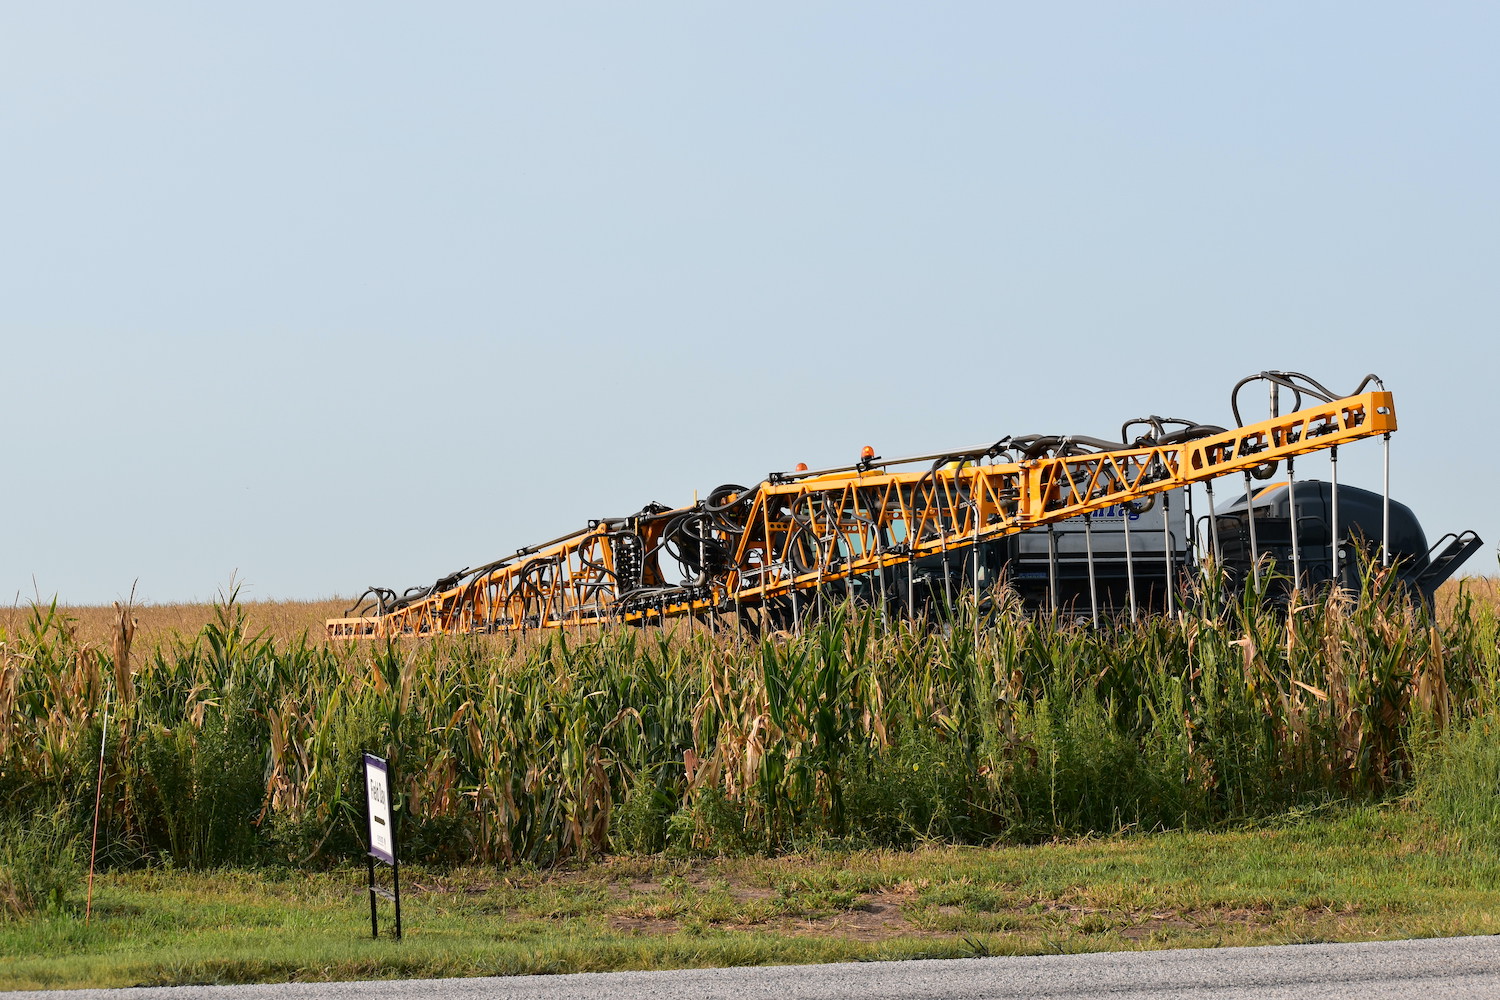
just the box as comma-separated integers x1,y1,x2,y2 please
327,391,1397,639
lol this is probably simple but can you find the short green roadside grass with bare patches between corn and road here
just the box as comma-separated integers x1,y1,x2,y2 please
0,804,1500,990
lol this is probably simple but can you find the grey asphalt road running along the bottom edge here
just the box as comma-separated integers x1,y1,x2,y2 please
11,937,1500,1000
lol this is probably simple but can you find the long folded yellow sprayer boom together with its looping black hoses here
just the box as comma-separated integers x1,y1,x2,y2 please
327,372,1397,639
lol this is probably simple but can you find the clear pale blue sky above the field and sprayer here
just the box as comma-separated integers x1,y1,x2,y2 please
0,1,1500,603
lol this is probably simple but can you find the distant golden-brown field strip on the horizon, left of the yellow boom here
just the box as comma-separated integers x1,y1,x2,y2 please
0,598,350,649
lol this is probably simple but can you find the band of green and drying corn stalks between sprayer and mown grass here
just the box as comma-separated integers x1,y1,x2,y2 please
0,570,1500,867
